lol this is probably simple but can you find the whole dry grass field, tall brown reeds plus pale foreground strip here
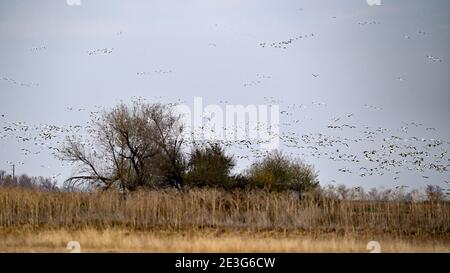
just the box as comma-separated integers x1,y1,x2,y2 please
0,188,450,252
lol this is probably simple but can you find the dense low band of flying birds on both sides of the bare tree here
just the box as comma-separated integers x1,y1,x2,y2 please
4,97,450,193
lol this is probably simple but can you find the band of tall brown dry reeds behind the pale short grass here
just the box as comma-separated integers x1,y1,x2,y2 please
0,188,450,235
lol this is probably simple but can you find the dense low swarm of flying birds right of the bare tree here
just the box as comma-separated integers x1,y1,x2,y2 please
174,93,450,194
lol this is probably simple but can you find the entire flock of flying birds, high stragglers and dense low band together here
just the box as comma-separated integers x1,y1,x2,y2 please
0,8,450,193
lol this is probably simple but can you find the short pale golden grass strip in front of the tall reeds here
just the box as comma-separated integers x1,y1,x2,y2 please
0,226,450,252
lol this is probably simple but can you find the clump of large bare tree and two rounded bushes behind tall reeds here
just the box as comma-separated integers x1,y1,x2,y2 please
53,102,318,194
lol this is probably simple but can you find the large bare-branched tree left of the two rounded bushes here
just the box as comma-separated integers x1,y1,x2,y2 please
60,101,185,192
